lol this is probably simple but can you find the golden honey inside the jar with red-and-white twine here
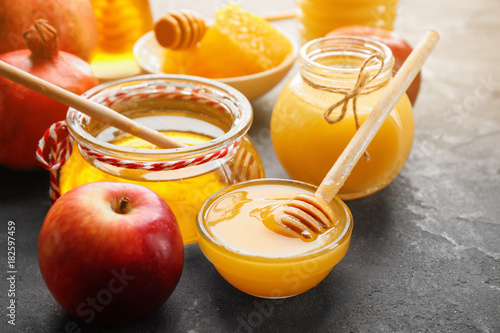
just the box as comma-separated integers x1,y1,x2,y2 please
60,131,263,244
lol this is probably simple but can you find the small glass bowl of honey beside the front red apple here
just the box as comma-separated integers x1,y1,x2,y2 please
197,179,353,298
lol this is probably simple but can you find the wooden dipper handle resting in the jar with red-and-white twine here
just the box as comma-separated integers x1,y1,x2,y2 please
0,61,186,148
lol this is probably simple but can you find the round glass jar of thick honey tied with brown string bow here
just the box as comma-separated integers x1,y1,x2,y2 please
271,37,414,200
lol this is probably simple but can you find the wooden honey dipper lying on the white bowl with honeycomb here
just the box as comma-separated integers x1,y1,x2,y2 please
154,9,295,50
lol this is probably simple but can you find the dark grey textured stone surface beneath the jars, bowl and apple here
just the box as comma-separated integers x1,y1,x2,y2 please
0,0,500,333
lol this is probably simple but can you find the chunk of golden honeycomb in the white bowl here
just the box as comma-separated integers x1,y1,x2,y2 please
162,4,292,79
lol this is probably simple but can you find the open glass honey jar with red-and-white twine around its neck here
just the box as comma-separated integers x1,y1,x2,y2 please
59,75,264,244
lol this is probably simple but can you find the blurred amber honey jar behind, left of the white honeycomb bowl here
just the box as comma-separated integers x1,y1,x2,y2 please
90,0,153,81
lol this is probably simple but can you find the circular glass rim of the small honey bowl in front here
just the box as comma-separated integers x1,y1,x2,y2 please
196,178,353,263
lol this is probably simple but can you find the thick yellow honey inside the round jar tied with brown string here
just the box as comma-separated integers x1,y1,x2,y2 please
271,50,414,200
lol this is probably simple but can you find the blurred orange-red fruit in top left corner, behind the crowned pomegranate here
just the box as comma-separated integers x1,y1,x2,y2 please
0,0,97,61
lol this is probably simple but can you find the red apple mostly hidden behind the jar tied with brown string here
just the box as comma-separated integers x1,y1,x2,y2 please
326,25,420,105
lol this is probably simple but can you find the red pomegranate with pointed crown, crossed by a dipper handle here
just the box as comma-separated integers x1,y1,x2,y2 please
0,20,99,169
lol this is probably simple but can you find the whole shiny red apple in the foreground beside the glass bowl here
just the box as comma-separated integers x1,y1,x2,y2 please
38,182,184,325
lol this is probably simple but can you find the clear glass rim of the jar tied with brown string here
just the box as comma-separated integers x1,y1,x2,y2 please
299,36,395,82
